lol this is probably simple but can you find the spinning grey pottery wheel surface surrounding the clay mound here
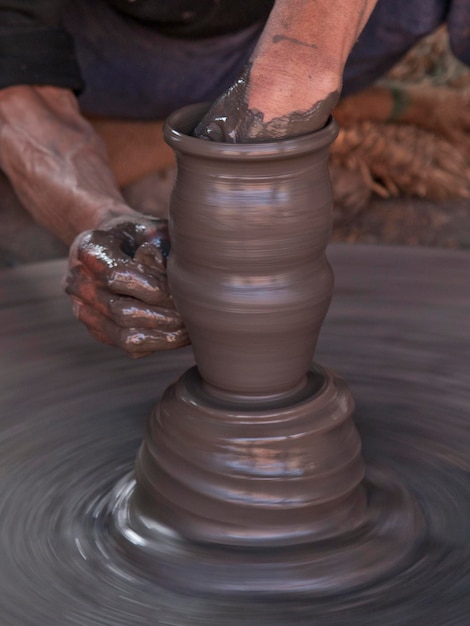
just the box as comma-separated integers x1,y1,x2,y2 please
0,246,470,626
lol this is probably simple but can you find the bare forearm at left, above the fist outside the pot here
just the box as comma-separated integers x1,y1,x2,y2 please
0,85,137,244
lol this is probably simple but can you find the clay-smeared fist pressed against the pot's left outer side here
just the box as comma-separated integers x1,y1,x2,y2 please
66,216,189,357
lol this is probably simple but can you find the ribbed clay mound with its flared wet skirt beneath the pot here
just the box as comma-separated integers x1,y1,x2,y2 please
109,365,424,597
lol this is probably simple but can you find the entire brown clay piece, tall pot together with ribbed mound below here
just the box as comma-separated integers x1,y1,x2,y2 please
111,105,423,596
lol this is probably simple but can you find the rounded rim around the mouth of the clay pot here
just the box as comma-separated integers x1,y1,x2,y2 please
163,102,339,160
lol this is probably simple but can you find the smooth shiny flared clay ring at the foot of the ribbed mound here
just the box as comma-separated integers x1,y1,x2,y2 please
110,468,424,600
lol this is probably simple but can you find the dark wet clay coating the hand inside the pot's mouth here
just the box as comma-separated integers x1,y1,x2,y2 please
194,63,339,143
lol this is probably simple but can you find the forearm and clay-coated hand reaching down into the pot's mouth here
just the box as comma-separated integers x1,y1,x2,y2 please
195,0,376,142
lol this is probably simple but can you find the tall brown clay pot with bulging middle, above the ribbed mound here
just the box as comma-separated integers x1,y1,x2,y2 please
165,105,337,396
